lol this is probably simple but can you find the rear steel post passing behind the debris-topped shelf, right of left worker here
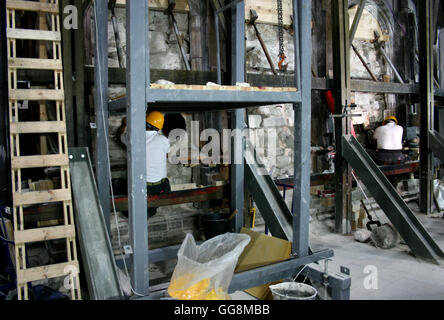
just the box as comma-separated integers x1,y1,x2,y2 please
231,1,245,232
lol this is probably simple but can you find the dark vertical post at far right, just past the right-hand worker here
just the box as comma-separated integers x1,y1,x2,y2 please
418,0,434,214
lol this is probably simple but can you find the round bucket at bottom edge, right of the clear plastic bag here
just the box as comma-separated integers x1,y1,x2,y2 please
270,282,318,300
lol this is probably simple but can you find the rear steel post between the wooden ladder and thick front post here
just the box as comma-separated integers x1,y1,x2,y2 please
94,0,111,233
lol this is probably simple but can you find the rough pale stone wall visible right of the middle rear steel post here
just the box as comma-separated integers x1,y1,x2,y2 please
246,1,396,178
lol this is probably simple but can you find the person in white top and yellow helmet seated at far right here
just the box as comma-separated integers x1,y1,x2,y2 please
370,116,406,164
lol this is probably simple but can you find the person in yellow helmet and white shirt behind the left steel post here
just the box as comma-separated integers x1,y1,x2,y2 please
117,111,171,218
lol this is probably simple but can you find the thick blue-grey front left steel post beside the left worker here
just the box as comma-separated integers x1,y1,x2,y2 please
126,1,150,296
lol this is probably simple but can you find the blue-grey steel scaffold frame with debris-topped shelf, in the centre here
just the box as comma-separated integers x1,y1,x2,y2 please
88,0,350,299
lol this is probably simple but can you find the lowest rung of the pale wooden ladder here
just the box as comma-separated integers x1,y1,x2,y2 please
17,261,79,284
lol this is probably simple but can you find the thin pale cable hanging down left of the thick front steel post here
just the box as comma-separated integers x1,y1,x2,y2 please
94,0,145,297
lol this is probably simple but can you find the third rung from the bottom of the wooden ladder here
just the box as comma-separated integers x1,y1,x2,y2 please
13,189,71,207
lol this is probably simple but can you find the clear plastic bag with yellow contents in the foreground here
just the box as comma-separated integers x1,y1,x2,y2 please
168,233,250,300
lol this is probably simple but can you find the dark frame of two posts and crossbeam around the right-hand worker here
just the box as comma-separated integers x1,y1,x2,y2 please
332,0,444,234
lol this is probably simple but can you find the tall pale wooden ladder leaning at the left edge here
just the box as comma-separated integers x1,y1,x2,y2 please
6,0,81,300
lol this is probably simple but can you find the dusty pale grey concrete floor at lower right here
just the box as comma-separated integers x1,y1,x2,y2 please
311,208,444,300
